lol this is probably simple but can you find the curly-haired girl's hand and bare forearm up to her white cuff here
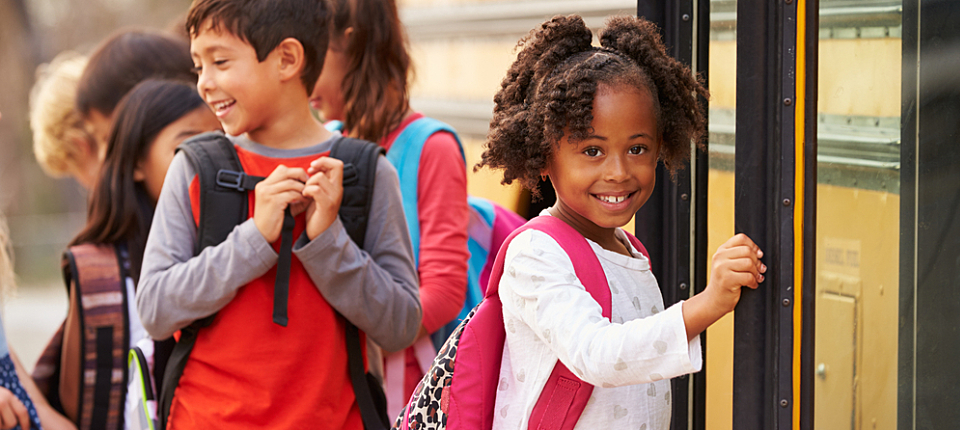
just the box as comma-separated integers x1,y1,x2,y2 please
683,233,767,339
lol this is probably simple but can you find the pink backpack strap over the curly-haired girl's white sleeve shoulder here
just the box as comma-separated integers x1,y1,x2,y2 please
528,216,612,430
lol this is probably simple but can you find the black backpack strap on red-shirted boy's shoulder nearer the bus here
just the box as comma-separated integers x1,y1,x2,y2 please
330,138,390,430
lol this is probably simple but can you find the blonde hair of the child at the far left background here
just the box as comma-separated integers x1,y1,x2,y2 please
30,51,96,177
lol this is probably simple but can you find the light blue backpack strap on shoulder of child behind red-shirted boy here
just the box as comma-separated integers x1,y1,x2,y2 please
387,117,466,267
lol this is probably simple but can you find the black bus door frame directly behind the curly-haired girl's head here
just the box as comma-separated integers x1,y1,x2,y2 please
635,0,710,430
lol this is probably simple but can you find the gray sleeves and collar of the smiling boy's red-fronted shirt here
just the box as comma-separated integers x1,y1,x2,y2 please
137,136,421,350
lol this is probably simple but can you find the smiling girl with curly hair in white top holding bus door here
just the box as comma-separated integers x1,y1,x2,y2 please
477,16,766,430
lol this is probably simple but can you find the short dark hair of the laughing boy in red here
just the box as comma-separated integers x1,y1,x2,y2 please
186,0,330,94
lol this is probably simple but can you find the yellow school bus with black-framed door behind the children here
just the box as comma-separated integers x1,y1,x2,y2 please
401,0,960,430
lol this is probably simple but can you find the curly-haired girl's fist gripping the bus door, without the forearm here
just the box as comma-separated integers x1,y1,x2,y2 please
704,233,767,315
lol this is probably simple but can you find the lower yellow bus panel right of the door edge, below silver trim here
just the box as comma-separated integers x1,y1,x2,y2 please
814,184,900,430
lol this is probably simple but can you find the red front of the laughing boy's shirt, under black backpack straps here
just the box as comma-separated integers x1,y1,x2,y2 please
168,147,366,430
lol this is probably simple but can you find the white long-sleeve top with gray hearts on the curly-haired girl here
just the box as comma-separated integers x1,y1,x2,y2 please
494,229,702,430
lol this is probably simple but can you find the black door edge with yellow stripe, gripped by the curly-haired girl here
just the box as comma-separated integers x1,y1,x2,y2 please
733,0,819,430
